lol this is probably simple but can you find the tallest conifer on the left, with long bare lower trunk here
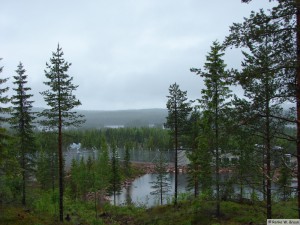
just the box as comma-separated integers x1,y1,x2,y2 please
41,45,83,221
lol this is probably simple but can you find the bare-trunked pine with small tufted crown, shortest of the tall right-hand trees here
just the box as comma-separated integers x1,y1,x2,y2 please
165,83,192,205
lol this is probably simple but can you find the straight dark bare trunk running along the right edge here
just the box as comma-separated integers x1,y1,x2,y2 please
295,0,300,219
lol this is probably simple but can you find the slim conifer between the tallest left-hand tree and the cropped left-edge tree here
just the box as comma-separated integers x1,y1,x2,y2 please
10,62,36,206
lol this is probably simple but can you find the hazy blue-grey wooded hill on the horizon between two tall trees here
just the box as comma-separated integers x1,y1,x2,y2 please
78,109,168,128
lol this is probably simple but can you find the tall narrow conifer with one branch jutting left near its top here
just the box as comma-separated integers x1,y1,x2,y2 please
191,41,231,216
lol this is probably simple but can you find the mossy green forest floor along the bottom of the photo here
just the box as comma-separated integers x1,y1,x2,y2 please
0,200,297,225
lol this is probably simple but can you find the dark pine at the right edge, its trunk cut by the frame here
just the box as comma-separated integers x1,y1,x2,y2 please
225,0,300,218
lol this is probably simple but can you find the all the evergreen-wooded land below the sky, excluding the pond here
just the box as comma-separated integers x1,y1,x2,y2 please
0,0,300,224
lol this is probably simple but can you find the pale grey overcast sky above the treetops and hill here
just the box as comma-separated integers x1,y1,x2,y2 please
0,0,271,110
